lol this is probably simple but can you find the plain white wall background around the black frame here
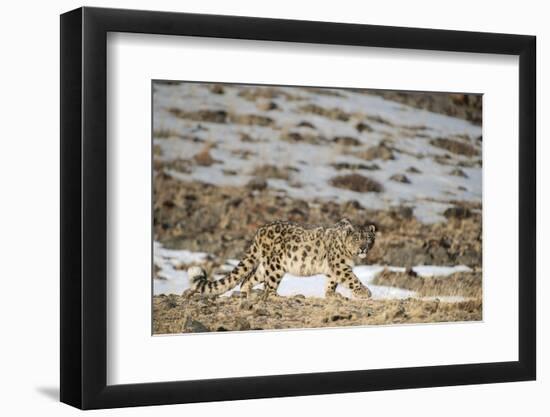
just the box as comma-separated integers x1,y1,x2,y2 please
0,0,550,417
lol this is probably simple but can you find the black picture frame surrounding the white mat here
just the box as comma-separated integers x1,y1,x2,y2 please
60,7,536,409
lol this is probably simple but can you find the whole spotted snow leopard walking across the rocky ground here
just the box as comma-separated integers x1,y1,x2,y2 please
189,219,376,298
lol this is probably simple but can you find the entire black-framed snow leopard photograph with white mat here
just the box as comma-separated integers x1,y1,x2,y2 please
61,8,536,409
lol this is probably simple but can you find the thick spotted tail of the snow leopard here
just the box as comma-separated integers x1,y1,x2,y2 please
188,243,258,296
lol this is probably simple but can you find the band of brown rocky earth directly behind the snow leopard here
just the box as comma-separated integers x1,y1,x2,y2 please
153,173,482,269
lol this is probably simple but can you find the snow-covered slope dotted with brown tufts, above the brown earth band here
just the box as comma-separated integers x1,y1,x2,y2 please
153,83,482,223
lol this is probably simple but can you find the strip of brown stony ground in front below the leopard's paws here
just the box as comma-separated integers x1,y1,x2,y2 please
153,295,482,334
